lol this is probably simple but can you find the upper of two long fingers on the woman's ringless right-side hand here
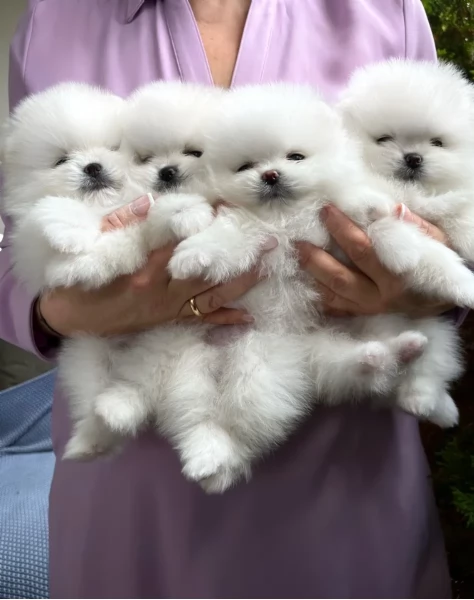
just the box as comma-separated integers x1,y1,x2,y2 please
321,206,391,284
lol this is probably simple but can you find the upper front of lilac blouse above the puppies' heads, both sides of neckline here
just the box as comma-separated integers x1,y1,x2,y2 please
24,0,405,103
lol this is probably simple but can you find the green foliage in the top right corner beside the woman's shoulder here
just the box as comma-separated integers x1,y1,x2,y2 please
423,0,474,80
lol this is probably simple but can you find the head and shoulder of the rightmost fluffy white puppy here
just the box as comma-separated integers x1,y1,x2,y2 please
340,60,474,262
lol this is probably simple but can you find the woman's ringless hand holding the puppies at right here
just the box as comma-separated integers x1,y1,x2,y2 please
299,205,454,317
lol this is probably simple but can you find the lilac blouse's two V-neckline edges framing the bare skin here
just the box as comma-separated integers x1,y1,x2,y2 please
164,0,275,87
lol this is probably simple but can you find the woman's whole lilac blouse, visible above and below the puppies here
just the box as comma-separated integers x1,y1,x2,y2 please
0,0,456,598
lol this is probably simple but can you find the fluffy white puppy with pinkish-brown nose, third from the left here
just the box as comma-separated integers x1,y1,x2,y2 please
170,85,457,489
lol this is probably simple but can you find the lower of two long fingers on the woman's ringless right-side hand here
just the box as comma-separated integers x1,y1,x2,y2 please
297,242,378,306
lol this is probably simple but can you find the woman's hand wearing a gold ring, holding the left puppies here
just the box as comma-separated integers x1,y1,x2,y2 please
37,196,264,336
